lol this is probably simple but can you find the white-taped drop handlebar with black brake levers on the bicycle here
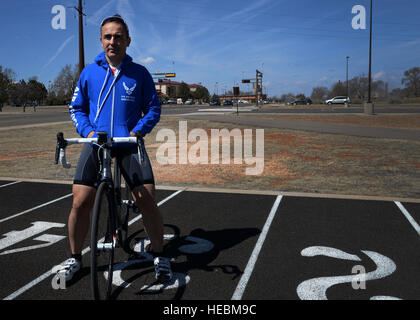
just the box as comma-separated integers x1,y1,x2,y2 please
54,131,145,169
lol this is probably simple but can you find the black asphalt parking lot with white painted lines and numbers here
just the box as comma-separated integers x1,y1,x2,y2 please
0,181,420,301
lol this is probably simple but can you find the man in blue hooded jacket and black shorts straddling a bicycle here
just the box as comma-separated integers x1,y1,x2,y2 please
56,15,172,282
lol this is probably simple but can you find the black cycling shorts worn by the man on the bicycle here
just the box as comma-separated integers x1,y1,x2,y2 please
73,144,155,190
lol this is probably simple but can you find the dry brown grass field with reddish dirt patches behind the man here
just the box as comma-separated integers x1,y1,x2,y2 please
0,111,420,199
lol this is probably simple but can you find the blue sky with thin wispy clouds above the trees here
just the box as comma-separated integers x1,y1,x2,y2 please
0,0,420,96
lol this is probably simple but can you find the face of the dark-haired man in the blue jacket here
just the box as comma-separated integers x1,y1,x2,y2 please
100,22,130,63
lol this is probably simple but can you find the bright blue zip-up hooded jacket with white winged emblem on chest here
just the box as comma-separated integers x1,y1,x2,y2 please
69,52,161,137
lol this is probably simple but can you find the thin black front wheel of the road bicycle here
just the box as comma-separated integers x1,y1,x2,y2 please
90,182,115,300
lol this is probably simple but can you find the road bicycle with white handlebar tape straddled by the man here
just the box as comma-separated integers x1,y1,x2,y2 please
55,131,145,300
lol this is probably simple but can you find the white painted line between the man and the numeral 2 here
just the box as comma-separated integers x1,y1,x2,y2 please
232,195,283,300
